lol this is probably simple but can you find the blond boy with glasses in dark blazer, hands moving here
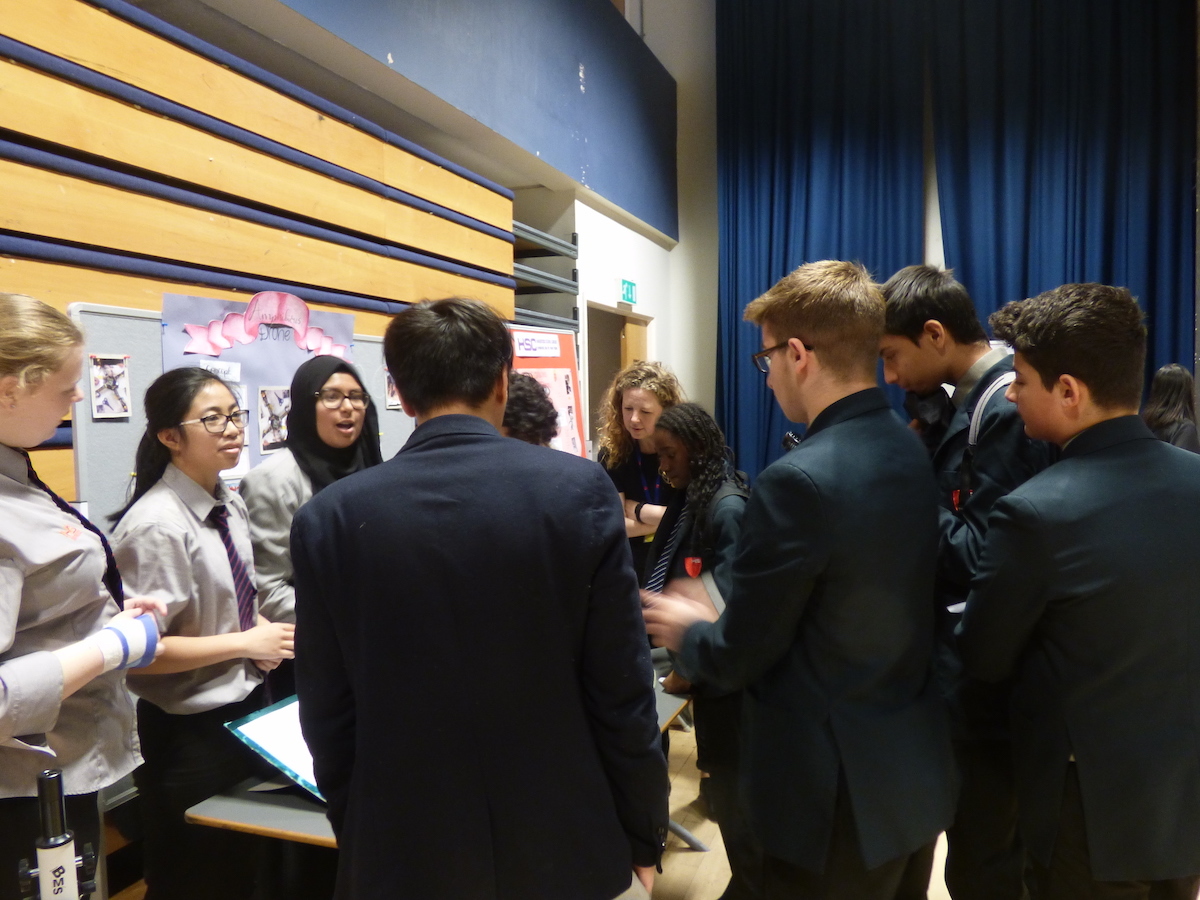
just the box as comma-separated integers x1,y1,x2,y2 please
643,260,955,900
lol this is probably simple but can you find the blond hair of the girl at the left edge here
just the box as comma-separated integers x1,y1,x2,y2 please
0,294,83,388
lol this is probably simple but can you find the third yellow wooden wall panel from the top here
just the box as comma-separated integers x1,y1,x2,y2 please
0,160,514,318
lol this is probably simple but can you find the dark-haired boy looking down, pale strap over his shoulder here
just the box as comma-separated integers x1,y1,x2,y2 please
880,265,1051,900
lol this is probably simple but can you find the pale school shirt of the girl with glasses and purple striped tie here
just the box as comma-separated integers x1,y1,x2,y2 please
113,464,263,715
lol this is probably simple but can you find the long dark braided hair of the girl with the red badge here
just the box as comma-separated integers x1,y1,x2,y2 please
656,403,750,556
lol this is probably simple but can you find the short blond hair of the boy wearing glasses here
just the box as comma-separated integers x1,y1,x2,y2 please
744,259,886,380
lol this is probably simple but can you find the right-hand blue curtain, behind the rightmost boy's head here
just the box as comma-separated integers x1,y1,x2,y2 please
929,0,1196,384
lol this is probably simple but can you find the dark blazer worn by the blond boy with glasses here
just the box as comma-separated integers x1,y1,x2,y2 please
679,388,956,872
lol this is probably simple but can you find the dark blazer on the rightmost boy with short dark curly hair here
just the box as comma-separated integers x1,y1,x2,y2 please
959,416,1200,881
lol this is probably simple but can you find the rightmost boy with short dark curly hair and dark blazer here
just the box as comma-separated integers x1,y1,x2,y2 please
959,284,1200,900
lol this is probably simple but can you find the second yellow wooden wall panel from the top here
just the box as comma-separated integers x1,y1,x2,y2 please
0,60,512,274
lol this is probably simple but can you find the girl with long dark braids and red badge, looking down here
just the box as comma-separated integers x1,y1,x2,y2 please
646,403,762,900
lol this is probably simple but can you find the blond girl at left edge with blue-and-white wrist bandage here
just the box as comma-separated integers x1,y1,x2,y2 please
0,294,164,900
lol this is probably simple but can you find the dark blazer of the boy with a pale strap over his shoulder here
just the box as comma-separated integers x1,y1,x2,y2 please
934,355,1057,739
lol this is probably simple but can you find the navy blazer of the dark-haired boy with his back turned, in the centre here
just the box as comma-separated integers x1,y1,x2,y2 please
292,415,667,900
